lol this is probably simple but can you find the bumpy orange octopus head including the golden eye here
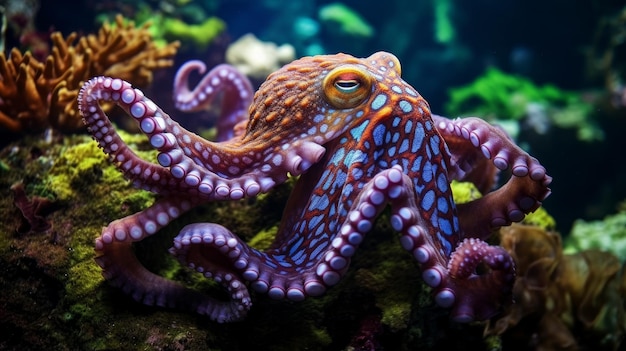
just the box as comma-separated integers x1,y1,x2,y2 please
244,52,427,144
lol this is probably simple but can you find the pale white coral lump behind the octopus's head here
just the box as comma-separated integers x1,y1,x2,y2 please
226,33,296,80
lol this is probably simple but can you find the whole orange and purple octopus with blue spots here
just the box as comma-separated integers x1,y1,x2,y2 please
79,52,552,322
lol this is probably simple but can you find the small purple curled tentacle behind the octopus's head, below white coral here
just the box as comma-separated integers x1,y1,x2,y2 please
174,60,253,141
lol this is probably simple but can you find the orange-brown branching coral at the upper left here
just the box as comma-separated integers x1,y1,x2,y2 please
0,16,179,133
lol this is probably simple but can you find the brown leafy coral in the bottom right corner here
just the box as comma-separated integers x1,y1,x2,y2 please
485,225,626,350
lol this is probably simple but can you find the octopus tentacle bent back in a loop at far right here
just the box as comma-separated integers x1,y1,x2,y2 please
434,116,552,238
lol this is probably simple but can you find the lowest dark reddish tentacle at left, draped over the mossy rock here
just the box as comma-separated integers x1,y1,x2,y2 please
96,198,250,322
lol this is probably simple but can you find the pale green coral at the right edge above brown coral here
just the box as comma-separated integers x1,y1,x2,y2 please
563,210,626,262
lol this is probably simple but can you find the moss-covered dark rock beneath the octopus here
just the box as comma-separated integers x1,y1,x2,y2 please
0,134,498,350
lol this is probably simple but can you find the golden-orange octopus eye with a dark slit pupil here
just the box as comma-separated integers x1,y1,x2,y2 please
322,66,372,109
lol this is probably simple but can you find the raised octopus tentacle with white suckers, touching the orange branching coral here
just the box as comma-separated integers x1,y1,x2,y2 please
79,77,325,204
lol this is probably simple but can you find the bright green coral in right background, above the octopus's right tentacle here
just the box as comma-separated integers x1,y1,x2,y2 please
445,67,604,141
